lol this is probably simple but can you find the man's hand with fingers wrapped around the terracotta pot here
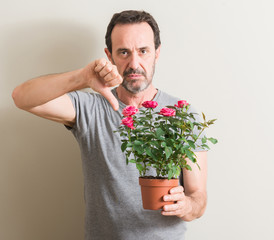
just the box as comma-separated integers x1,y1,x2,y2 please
162,186,192,218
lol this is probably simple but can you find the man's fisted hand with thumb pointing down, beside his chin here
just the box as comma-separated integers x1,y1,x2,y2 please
82,58,123,111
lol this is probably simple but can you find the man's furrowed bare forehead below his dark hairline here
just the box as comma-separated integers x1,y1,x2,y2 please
111,22,154,48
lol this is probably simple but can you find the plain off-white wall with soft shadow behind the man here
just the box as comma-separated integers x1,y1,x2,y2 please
0,0,274,240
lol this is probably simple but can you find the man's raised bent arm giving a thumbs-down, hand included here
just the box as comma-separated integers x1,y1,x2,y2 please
12,59,122,126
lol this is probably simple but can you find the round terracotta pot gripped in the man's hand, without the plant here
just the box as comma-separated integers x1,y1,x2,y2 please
139,177,179,210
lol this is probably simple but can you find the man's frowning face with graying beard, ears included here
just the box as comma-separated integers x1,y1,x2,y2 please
105,22,160,94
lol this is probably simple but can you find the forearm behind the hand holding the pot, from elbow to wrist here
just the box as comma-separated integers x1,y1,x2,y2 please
181,192,207,222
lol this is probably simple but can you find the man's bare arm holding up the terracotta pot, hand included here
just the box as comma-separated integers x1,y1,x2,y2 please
162,152,207,221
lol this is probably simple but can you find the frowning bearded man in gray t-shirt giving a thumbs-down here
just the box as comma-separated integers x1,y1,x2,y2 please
13,11,207,240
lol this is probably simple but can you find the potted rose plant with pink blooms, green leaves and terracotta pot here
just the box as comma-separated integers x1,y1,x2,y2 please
115,100,217,209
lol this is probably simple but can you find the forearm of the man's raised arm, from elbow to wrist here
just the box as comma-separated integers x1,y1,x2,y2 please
12,69,86,110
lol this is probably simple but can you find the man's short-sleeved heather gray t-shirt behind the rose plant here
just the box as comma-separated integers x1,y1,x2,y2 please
68,89,191,240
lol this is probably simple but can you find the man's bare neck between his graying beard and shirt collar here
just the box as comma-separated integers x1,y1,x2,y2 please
116,84,157,108
